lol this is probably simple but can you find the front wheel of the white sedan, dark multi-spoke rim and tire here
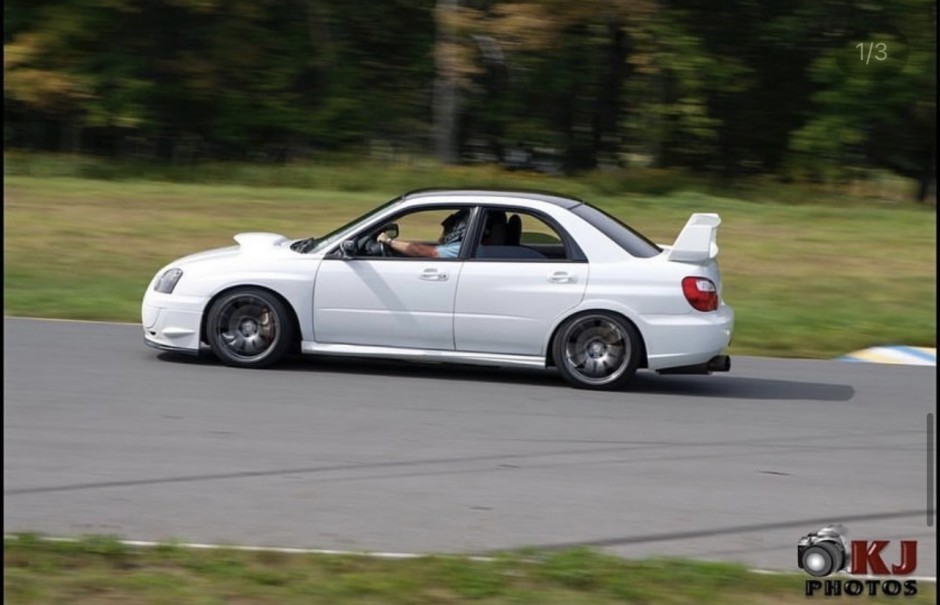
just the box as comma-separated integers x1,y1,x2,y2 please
206,288,296,368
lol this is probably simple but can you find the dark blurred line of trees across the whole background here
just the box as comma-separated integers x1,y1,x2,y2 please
4,0,936,198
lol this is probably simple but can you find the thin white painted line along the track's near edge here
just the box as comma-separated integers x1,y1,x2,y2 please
3,534,937,583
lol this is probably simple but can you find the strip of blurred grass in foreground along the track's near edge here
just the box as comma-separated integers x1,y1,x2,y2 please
3,535,936,605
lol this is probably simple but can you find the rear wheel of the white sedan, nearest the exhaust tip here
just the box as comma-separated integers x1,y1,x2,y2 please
552,311,642,390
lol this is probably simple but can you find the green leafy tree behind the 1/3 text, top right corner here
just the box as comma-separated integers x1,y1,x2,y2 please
790,0,936,201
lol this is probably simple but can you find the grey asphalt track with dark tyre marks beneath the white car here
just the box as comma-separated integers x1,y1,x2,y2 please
3,318,937,576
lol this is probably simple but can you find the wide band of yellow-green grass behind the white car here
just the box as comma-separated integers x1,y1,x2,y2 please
4,156,936,358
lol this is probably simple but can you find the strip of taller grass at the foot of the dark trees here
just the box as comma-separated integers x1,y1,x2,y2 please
4,151,924,206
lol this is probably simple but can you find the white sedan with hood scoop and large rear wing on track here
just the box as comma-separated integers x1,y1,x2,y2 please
142,189,734,389
